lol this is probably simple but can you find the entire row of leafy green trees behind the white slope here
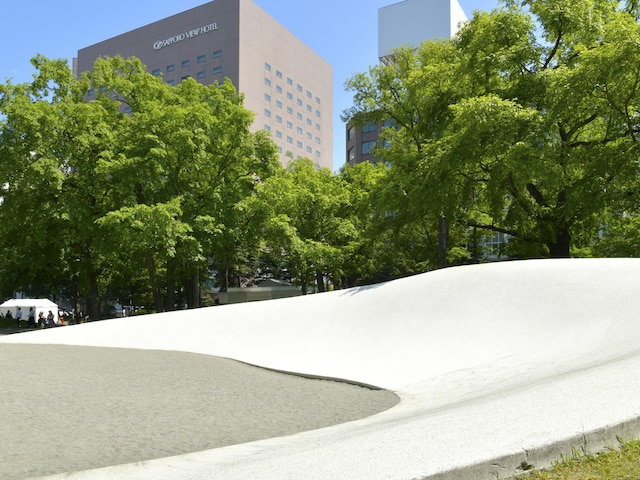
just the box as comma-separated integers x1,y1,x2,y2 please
5,0,640,318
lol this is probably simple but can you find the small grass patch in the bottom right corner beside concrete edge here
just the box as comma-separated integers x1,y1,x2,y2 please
516,440,640,480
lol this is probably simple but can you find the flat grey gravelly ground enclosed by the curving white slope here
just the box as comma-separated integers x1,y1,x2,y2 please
0,344,399,480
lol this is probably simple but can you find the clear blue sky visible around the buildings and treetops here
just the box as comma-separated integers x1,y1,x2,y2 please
0,0,499,170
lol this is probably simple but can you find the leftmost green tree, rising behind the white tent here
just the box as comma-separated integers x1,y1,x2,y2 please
0,56,113,316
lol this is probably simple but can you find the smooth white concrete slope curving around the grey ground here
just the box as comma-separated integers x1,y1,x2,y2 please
0,259,640,480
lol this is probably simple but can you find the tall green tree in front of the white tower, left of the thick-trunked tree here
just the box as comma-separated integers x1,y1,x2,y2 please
343,41,472,266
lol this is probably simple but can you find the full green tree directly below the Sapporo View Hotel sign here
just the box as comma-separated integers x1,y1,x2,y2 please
88,57,277,311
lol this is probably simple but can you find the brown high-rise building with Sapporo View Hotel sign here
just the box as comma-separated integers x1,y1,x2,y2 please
75,0,333,169
